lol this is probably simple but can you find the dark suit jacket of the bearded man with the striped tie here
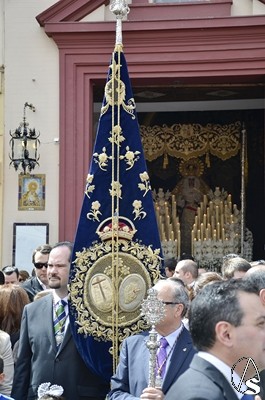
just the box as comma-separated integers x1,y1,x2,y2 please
11,295,109,400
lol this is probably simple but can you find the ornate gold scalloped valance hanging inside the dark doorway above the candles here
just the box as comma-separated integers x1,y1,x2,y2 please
140,121,241,161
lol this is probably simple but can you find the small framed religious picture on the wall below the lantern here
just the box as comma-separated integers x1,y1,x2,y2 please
18,174,45,211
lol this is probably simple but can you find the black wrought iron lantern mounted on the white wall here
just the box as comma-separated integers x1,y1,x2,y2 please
9,103,40,175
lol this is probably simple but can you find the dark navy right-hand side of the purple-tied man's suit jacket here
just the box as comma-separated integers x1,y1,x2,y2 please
163,328,192,393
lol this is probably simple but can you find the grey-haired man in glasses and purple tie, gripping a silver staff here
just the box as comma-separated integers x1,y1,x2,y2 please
108,278,195,400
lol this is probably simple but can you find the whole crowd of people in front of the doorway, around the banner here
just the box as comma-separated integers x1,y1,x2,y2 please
0,242,265,400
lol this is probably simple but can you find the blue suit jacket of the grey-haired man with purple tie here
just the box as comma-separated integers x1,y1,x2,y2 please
108,328,195,400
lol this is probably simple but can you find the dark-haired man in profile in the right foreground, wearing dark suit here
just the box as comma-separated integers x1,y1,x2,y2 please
166,279,265,400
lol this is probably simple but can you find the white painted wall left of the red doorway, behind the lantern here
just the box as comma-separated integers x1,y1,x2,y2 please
1,0,59,269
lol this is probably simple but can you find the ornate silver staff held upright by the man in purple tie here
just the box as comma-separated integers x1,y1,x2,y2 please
141,289,165,388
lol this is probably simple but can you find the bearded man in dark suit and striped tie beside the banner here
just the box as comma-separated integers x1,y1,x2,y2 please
12,242,109,400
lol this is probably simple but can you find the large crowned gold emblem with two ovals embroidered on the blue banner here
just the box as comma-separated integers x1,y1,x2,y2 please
71,217,161,341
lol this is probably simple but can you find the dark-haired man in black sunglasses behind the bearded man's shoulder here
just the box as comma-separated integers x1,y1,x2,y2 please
21,244,52,301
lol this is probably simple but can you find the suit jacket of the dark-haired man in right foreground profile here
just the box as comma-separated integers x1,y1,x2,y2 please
166,355,238,400
